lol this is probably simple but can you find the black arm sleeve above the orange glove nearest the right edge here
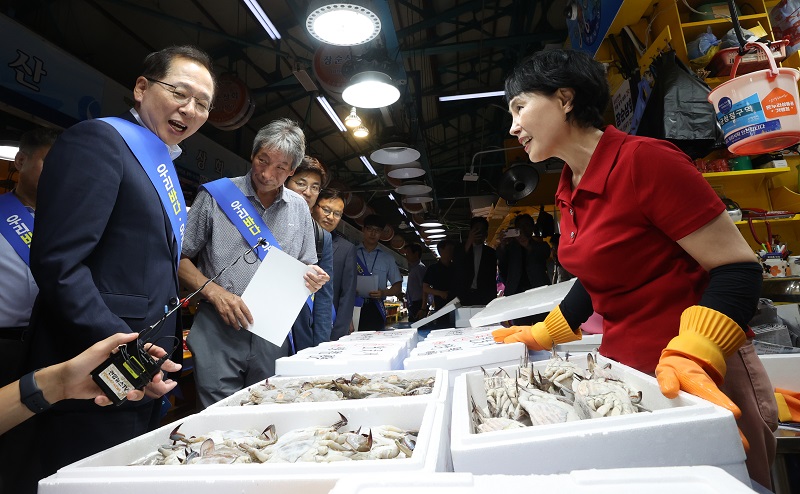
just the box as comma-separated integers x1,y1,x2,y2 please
700,262,763,329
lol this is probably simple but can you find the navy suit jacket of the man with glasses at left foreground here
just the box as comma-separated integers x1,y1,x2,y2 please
30,114,178,368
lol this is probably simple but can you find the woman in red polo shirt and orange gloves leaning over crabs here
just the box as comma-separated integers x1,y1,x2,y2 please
494,50,777,487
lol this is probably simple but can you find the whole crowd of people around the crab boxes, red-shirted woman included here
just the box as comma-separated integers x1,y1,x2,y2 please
0,42,776,493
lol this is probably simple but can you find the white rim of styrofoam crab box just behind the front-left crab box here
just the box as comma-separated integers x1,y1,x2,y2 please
206,369,449,413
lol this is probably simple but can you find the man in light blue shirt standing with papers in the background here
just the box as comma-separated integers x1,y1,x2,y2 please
356,214,403,331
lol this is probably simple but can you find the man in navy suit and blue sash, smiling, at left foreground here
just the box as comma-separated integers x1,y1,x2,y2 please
30,46,209,475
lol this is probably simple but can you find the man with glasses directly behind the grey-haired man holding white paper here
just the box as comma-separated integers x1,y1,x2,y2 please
285,156,333,352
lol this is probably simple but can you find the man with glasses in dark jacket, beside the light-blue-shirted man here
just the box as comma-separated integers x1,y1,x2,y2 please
311,189,357,341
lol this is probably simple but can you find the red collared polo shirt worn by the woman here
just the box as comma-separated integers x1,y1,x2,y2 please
556,126,725,373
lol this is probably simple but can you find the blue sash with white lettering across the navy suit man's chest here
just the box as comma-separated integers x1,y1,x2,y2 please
98,117,186,266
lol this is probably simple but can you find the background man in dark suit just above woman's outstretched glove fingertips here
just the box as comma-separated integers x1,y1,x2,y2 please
455,216,497,306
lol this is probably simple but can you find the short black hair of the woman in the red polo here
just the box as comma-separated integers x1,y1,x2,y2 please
505,49,611,129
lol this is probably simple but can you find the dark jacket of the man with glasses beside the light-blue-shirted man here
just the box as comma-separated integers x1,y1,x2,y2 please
331,232,357,341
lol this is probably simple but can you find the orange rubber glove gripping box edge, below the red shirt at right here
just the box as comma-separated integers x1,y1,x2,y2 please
656,305,750,451
